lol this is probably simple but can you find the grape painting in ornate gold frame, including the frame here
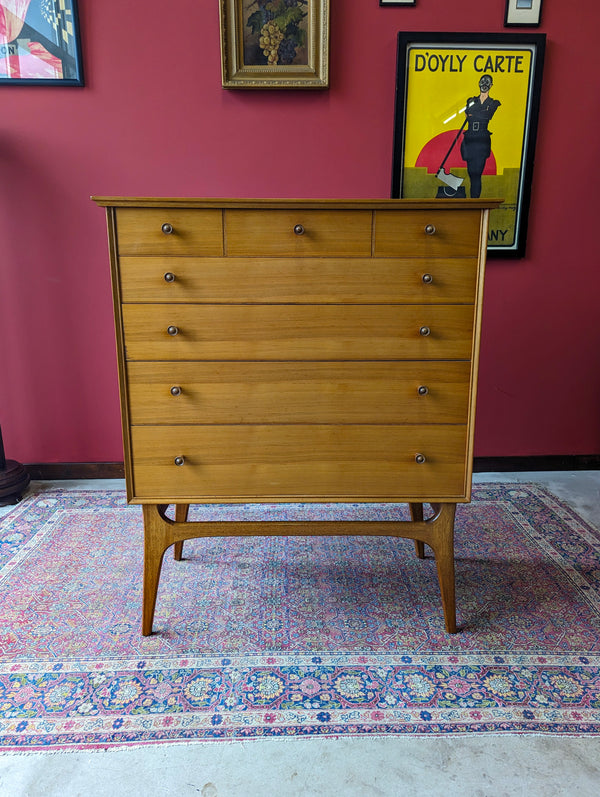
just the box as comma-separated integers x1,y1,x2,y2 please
220,0,329,89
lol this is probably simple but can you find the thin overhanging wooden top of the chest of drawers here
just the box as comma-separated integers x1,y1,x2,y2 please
91,196,504,210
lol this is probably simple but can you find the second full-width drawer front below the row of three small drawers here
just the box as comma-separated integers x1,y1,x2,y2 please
123,304,473,361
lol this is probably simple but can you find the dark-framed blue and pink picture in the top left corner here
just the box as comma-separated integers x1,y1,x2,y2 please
0,0,83,86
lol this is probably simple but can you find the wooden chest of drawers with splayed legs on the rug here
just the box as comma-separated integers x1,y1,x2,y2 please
94,197,498,634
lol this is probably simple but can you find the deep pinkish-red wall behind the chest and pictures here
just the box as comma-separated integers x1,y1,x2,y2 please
0,0,600,462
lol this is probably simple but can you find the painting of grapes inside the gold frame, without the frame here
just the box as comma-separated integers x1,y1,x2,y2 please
242,0,310,66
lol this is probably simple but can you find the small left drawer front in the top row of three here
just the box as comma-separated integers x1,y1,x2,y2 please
116,208,223,256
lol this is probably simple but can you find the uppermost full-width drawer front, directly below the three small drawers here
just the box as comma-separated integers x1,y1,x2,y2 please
120,257,477,304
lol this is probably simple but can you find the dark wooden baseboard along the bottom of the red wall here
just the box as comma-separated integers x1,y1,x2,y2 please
25,454,600,481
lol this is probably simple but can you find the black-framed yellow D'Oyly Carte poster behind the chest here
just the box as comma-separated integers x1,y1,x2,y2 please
392,33,546,257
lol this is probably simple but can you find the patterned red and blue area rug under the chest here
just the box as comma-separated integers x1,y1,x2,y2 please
0,484,600,751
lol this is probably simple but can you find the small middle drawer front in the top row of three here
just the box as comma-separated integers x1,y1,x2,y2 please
225,208,372,257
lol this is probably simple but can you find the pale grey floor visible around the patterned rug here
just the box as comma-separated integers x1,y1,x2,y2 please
0,471,600,797
